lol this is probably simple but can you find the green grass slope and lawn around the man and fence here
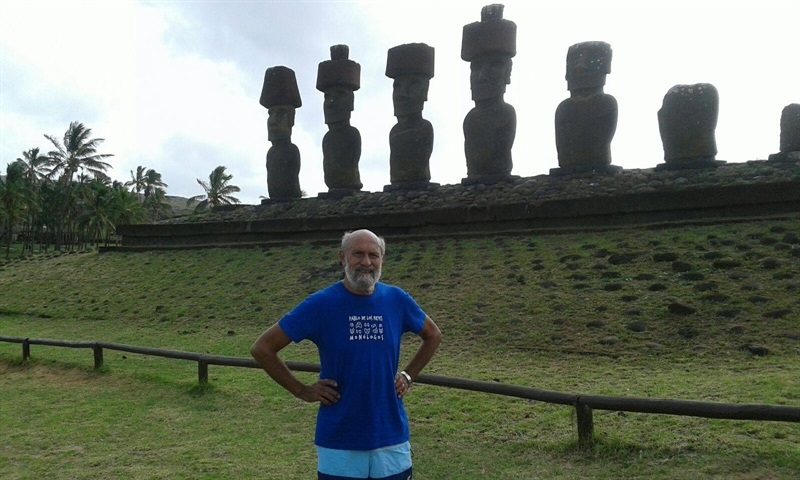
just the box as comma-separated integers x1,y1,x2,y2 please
0,217,800,480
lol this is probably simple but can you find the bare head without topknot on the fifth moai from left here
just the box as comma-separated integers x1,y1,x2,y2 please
565,42,612,93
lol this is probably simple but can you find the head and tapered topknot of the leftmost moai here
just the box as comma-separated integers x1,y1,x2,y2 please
259,66,303,142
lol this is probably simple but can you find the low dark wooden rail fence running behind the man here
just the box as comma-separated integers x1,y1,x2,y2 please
0,335,800,447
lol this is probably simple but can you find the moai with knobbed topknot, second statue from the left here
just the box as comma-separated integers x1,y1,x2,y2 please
317,45,363,197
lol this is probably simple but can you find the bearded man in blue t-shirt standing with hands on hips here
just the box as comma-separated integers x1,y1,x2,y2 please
251,230,442,480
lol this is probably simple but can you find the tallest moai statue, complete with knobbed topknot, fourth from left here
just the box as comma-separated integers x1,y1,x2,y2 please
461,4,517,185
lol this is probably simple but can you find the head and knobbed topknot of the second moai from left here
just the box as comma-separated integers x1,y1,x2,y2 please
317,45,361,124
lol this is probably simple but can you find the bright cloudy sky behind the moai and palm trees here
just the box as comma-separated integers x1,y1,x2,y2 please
0,0,800,204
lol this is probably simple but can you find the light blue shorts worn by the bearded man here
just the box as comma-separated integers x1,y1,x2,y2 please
317,442,411,480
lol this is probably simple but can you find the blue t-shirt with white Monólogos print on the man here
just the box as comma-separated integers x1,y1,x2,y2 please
278,282,425,450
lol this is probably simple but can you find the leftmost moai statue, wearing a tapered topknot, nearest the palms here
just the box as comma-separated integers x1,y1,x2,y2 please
259,67,303,203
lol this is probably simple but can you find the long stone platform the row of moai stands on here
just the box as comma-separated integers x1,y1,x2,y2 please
114,160,800,251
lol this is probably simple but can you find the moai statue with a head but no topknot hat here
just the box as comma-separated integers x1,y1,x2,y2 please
550,42,621,175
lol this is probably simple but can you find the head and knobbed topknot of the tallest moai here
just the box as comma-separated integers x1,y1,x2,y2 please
461,4,517,102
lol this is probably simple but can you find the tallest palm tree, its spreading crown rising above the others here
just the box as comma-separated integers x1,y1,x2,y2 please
45,122,113,250
